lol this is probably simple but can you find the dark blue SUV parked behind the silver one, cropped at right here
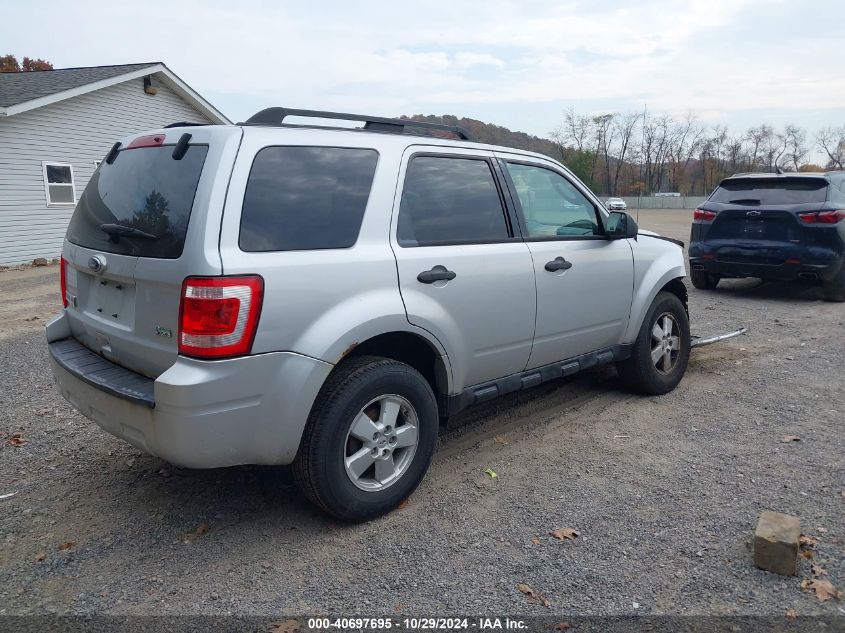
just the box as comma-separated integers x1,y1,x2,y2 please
689,171,845,301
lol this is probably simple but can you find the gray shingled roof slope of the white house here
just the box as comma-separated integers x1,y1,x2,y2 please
0,62,161,108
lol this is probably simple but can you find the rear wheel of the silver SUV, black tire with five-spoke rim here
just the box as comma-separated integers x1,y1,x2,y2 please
293,356,439,521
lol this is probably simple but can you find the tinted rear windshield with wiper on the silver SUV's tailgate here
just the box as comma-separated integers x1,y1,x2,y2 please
67,145,208,259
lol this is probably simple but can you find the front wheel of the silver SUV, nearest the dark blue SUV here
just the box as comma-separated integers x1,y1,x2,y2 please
617,291,691,395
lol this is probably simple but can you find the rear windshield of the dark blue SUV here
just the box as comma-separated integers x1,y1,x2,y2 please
709,178,827,205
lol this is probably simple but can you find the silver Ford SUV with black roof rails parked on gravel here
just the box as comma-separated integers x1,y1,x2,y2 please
47,108,690,520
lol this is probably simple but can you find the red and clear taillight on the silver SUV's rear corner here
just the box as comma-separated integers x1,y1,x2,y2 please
179,275,264,358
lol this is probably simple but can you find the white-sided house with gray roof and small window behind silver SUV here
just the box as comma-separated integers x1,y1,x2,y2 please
0,62,231,265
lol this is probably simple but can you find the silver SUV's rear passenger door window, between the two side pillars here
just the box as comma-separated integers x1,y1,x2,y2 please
397,156,510,246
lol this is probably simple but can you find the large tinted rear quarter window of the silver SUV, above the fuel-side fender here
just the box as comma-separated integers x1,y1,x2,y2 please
239,147,378,252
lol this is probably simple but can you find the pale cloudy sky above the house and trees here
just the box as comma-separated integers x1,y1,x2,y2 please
0,0,845,151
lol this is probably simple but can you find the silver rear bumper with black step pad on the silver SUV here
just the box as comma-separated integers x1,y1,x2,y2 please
48,314,332,468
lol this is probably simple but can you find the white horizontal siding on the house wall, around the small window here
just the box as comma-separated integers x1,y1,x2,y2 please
0,79,209,265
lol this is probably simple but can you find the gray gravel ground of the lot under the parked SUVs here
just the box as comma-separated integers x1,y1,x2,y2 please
0,211,845,617
